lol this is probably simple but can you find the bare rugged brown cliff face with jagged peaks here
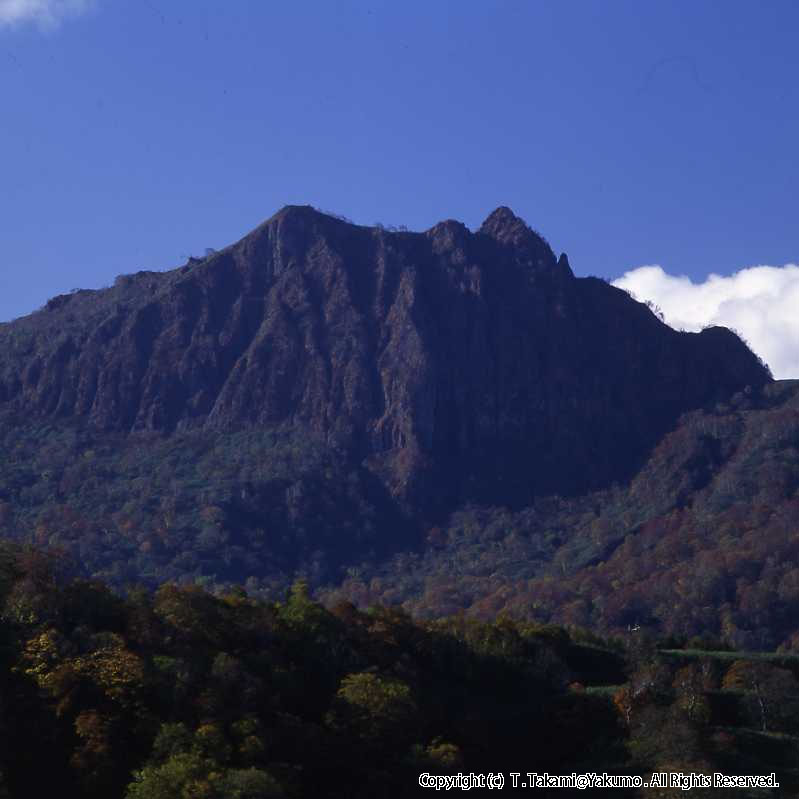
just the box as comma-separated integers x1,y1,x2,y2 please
0,207,770,506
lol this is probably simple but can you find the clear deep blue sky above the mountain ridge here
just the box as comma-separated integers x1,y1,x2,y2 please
0,0,799,320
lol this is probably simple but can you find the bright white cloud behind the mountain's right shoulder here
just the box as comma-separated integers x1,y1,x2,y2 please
613,264,799,379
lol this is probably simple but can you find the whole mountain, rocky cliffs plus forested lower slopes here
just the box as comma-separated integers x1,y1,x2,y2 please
0,206,799,648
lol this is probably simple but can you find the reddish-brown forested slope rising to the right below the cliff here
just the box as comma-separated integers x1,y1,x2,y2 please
329,381,799,650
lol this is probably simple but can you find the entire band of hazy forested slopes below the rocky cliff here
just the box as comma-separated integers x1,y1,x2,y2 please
0,381,799,649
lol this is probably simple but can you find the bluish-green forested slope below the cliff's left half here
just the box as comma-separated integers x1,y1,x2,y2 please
0,420,418,596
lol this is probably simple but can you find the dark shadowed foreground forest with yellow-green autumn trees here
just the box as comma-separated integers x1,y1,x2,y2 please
0,545,799,799
